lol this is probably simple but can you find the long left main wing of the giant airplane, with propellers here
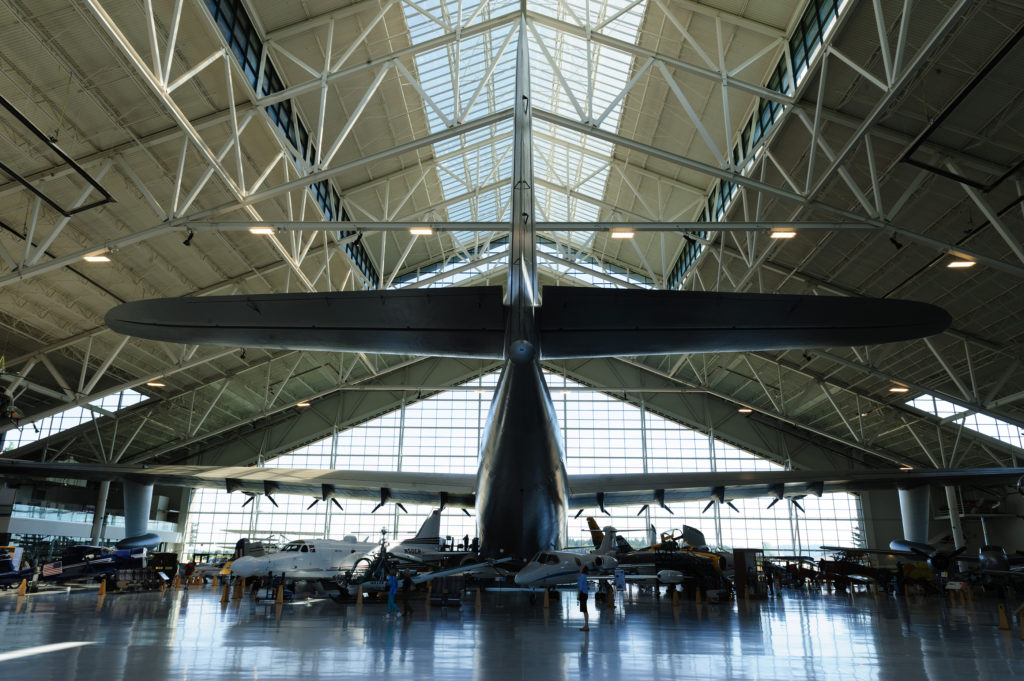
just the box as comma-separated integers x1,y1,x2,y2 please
0,459,476,508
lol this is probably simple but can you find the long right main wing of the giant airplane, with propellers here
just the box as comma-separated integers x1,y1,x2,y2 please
568,468,1024,509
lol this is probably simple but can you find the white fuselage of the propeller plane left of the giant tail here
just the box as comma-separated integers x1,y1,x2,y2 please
230,537,377,580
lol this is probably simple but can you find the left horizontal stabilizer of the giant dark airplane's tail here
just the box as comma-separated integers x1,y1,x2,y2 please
106,287,505,359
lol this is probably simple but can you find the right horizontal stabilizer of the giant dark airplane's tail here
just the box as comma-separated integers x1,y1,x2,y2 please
539,286,951,359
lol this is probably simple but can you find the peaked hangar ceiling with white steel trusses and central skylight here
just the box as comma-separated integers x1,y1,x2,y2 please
0,0,1024,477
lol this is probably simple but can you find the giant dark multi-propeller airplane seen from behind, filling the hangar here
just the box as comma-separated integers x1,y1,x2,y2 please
0,22,1024,559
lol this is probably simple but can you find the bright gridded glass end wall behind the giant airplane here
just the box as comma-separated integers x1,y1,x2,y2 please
185,374,862,554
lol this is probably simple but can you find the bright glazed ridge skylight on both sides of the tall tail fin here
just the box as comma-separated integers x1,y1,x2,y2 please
402,0,646,256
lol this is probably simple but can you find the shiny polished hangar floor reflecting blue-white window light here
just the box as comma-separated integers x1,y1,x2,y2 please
0,587,1024,681
